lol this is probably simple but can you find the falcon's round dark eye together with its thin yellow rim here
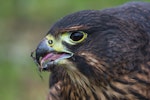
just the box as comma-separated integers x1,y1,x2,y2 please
70,31,87,42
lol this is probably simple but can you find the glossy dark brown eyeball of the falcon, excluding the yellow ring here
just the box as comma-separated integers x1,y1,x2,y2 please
70,32,84,41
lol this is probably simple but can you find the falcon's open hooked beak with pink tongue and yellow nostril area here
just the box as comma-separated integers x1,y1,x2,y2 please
31,38,73,71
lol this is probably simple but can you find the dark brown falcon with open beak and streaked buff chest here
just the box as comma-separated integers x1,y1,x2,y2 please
32,2,150,100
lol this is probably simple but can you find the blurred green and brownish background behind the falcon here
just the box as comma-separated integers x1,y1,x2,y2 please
0,0,150,100
